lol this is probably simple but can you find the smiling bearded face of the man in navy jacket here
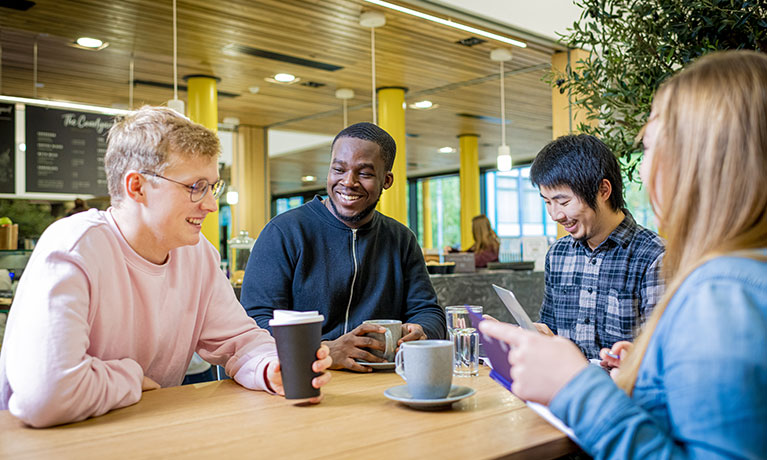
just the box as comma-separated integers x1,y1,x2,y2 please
326,137,394,228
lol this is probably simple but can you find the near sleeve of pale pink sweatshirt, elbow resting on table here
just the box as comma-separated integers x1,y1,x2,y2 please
2,241,144,427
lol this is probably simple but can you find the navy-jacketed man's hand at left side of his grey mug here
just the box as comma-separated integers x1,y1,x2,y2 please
324,323,390,372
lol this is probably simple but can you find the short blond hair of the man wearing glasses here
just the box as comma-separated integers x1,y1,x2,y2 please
104,106,221,205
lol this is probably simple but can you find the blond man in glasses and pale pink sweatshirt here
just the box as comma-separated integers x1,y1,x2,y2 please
0,107,330,427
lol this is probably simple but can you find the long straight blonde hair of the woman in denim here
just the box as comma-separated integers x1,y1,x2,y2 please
617,51,767,394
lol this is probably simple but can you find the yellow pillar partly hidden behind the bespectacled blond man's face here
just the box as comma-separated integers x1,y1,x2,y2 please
184,75,220,249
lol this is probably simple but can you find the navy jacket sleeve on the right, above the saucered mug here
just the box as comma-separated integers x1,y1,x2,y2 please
404,233,447,339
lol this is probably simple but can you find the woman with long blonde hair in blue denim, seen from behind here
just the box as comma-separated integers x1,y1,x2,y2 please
480,51,767,458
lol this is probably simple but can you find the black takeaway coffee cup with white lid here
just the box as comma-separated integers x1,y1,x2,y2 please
269,310,324,399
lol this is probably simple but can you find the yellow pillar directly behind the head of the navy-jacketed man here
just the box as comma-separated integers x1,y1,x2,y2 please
378,87,407,225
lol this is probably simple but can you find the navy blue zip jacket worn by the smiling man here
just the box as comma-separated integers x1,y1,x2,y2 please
240,197,446,340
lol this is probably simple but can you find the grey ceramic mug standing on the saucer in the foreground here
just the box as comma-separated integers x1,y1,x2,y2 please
395,340,453,399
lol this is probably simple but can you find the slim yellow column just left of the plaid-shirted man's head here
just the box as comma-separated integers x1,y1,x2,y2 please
458,134,480,251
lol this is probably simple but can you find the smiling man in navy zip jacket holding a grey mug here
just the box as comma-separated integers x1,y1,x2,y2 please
240,123,445,372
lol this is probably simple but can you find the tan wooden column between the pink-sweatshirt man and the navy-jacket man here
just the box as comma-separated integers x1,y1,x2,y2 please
232,125,271,238
